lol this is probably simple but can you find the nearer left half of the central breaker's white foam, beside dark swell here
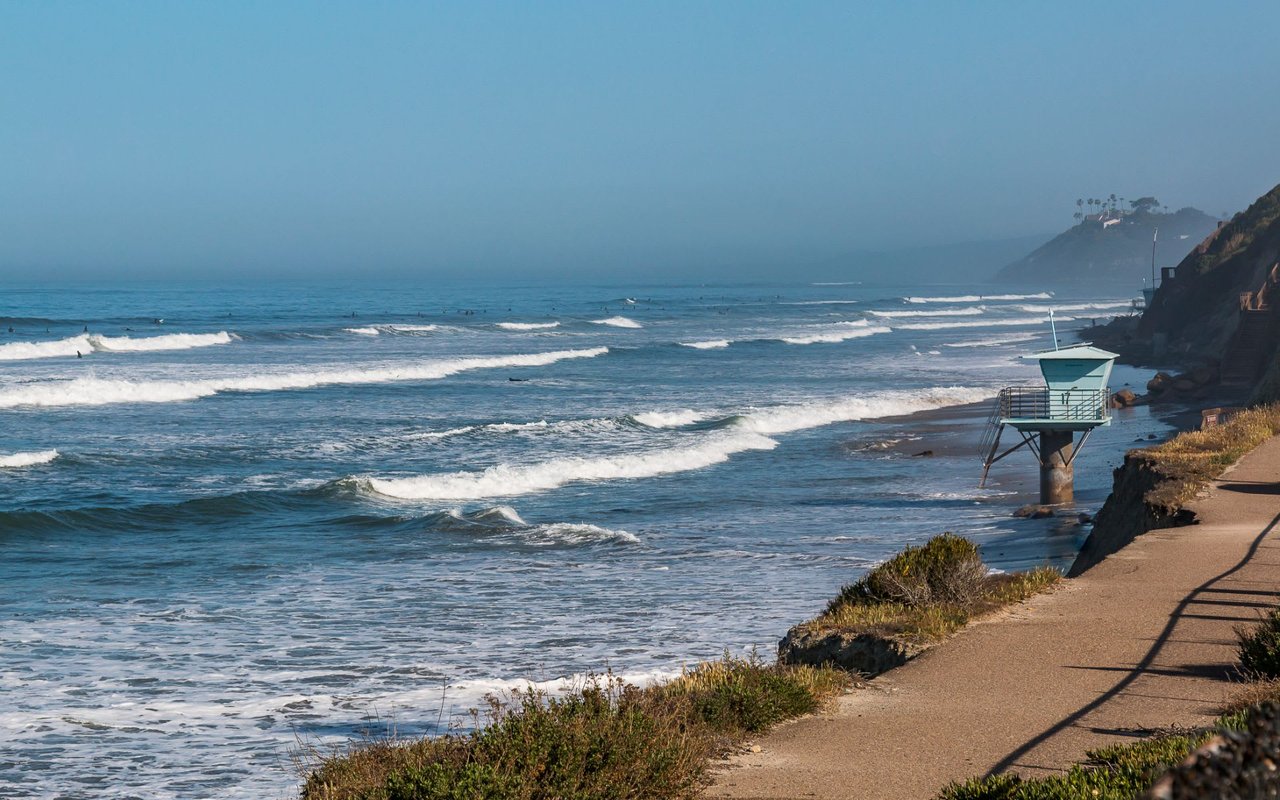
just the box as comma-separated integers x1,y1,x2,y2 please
362,431,778,500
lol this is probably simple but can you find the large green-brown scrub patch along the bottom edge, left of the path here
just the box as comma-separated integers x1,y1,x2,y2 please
302,655,851,800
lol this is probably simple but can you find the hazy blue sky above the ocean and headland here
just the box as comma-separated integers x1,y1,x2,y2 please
0,0,1280,278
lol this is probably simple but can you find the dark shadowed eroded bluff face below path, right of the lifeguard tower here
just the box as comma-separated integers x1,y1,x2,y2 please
1066,449,1196,577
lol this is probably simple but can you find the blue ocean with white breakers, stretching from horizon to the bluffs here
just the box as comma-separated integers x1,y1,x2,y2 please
0,283,1170,800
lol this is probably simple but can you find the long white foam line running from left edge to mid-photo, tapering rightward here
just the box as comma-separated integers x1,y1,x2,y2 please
0,347,609,408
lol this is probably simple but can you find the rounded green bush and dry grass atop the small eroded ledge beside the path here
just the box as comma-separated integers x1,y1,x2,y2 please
799,532,1062,643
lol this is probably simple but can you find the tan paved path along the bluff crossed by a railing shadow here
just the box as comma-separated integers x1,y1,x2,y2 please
707,438,1280,800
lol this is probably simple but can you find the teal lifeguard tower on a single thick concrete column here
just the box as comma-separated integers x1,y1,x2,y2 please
982,344,1117,506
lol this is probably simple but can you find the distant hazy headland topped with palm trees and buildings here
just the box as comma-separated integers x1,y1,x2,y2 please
995,207,1217,288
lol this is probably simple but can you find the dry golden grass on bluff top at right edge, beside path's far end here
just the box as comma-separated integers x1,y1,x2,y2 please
1140,404,1280,509
